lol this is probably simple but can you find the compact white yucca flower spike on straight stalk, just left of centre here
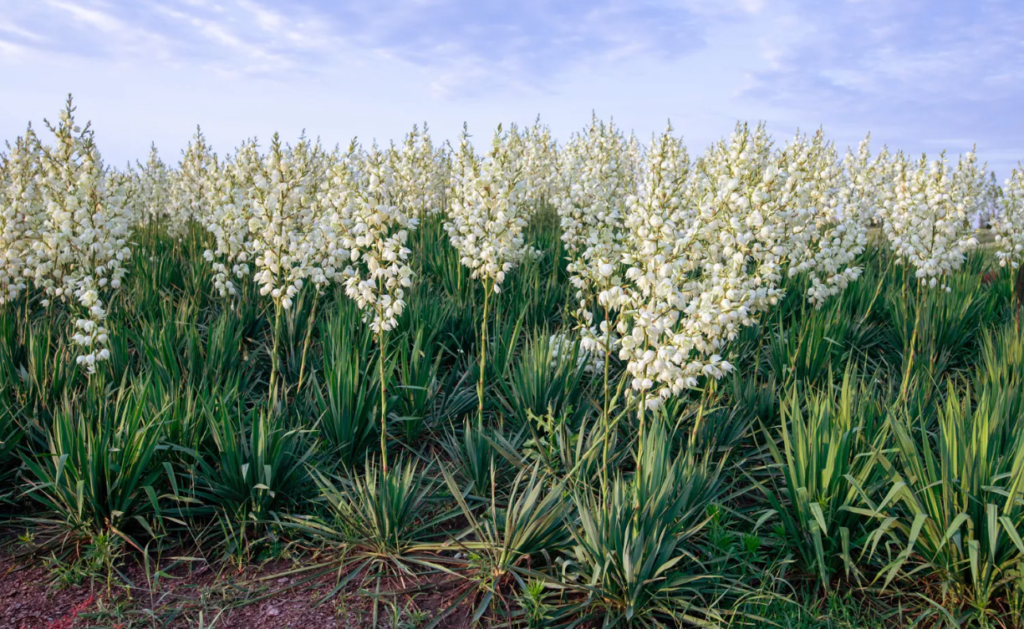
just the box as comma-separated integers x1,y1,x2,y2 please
444,125,528,292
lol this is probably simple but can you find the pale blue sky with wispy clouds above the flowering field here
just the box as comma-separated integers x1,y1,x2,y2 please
0,0,1024,179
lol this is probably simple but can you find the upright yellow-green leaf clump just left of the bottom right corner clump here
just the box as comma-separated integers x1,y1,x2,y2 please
751,369,885,592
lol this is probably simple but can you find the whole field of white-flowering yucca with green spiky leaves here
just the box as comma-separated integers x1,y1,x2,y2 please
0,96,1024,629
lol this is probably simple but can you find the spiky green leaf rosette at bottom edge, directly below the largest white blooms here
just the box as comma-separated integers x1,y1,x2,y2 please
562,422,723,627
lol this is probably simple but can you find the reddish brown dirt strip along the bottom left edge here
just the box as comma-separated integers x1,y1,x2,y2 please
0,548,470,629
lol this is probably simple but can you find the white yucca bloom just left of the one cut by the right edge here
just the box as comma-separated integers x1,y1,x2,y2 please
882,152,984,288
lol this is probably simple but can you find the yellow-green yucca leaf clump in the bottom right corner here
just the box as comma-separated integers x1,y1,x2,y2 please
858,379,1024,625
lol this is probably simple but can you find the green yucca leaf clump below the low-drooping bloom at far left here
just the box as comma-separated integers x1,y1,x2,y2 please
25,381,166,549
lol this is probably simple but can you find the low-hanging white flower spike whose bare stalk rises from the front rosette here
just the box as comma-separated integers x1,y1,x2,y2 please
332,142,419,335
